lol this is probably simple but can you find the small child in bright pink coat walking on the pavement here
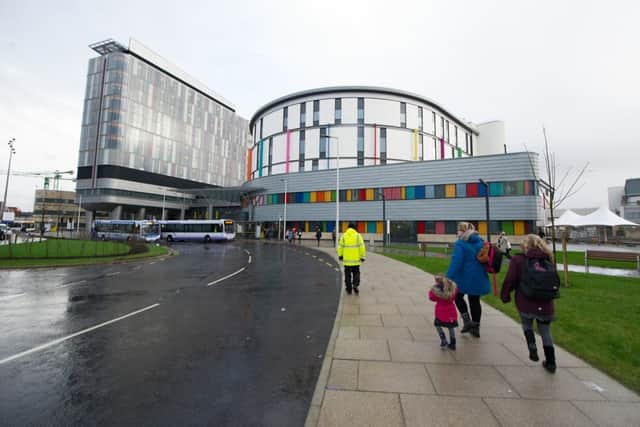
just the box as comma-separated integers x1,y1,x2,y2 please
429,276,458,350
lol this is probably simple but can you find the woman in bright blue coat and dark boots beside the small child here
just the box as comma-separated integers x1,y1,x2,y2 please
446,222,491,338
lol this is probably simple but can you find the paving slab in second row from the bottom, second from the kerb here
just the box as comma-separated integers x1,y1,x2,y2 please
358,362,435,394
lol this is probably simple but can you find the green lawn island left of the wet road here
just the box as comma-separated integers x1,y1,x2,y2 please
0,240,168,268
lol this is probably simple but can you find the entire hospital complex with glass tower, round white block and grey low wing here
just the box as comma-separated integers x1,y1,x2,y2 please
76,40,543,241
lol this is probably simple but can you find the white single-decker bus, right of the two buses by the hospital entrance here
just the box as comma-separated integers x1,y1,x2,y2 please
160,219,236,243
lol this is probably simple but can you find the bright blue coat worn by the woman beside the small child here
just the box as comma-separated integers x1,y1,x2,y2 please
447,232,491,295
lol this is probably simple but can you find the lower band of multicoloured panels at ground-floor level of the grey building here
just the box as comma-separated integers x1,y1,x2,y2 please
270,220,536,236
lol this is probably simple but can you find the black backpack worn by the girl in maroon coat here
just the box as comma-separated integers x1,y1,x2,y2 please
520,258,560,300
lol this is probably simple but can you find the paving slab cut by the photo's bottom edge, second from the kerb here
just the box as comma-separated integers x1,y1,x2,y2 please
400,394,499,427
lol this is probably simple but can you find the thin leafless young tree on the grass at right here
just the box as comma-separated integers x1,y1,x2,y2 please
525,127,589,286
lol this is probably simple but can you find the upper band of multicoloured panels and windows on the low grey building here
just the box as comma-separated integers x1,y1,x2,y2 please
255,181,537,206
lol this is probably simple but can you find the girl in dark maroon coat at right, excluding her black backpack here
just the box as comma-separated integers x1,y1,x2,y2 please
500,234,556,373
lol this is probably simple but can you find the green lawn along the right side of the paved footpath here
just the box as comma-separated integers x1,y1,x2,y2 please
387,254,640,393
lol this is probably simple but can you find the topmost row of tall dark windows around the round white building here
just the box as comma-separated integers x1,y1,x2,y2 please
254,98,473,156
